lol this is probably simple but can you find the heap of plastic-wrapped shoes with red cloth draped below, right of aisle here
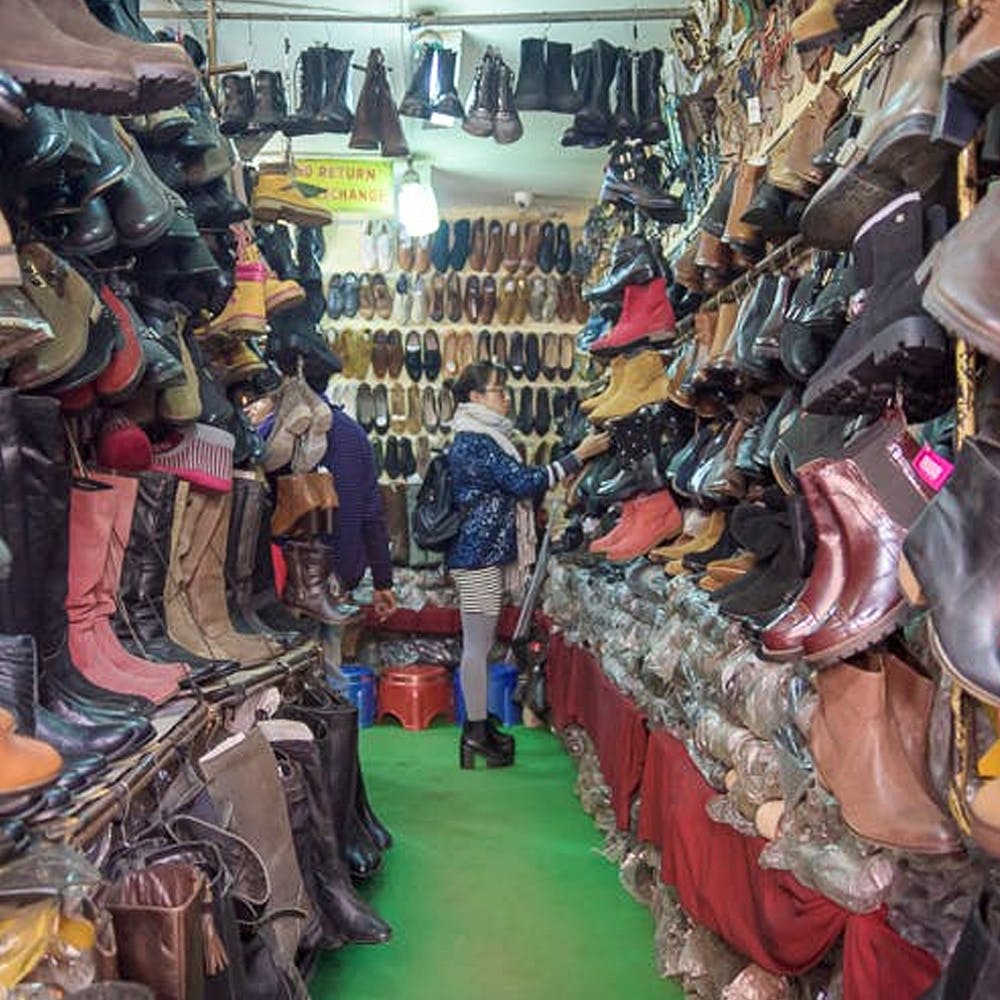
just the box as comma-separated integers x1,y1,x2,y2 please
544,557,982,998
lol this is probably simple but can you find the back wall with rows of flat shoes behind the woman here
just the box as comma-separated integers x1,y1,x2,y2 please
323,213,590,566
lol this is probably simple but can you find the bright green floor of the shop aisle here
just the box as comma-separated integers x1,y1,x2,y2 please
310,725,683,1000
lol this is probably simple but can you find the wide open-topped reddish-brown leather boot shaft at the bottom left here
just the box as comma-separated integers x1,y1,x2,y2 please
104,861,210,1000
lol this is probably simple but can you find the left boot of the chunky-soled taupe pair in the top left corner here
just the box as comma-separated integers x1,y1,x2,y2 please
0,0,141,115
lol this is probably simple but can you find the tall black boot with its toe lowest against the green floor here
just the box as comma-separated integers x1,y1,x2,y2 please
271,723,392,948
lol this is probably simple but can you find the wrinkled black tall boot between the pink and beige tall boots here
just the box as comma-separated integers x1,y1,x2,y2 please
113,472,239,681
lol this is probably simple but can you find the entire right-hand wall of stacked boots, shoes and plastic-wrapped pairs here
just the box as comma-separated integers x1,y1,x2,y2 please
548,0,1000,1000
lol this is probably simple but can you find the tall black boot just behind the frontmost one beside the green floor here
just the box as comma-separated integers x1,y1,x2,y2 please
279,685,382,878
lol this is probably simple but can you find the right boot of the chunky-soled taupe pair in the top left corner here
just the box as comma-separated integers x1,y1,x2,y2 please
32,0,198,113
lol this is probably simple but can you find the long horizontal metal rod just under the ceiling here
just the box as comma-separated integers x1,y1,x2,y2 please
142,7,690,28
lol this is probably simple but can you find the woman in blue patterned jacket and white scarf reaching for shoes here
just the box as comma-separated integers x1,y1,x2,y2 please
445,361,608,768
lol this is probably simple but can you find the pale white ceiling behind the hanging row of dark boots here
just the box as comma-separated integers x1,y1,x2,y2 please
152,0,676,210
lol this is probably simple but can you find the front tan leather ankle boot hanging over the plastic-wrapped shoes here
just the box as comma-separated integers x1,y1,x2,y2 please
809,658,960,854
